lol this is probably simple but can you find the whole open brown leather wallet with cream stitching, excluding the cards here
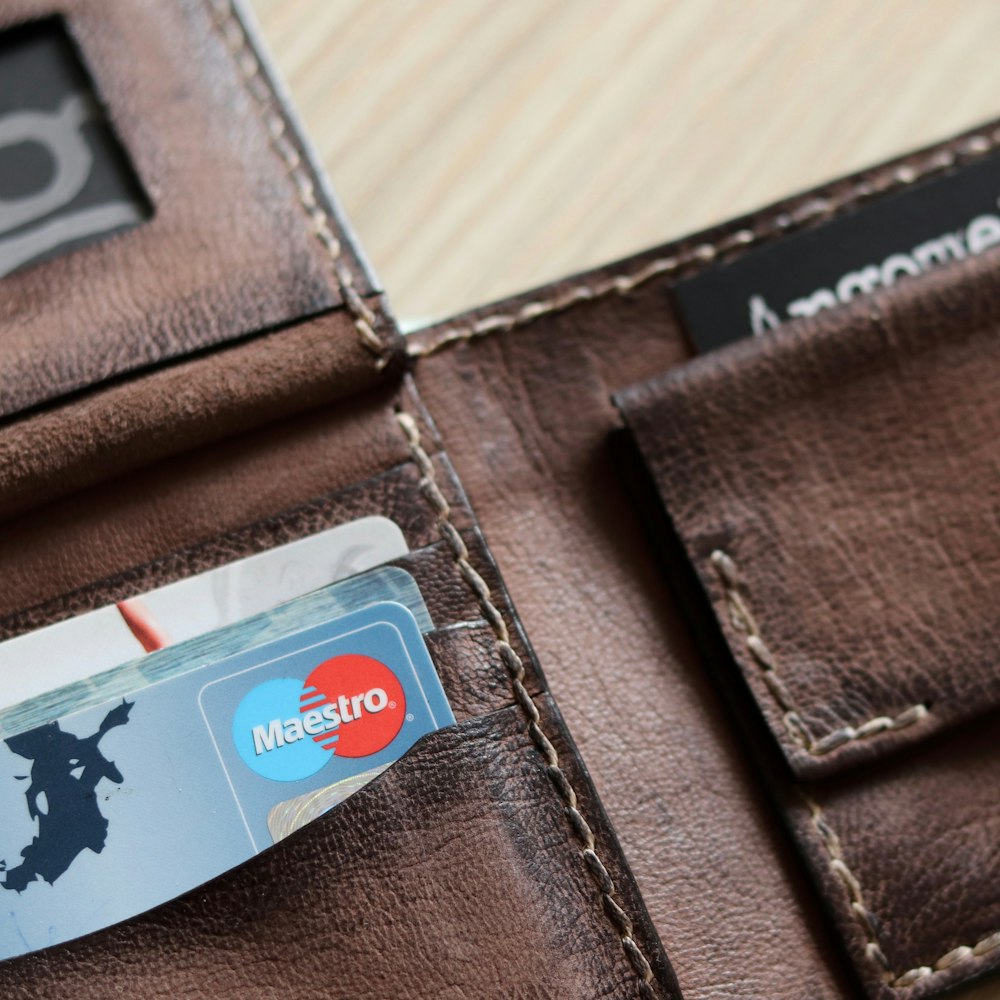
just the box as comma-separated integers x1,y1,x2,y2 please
0,0,1000,1000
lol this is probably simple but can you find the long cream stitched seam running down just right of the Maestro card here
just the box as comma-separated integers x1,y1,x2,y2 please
396,409,655,1000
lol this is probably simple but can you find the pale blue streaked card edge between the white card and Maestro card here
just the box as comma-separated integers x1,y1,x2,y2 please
0,566,434,738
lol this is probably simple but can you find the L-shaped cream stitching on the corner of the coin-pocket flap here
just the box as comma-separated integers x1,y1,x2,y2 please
711,549,930,757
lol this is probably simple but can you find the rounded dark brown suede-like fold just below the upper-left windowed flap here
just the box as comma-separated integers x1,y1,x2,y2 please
0,299,396,516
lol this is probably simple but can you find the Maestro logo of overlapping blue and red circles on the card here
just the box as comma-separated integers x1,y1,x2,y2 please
233,653,406,781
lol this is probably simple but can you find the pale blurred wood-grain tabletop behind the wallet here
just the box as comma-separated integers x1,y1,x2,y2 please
252,0,1000,323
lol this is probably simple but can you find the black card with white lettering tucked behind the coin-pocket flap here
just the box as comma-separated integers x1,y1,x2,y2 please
674,146,1000,351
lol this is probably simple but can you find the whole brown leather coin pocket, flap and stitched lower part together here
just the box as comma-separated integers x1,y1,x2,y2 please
620,248,1000,1000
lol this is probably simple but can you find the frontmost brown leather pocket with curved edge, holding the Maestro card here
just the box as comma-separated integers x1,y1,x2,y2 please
0,699,676,1000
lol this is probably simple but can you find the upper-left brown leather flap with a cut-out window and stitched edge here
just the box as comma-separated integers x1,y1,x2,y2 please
0,0,377,417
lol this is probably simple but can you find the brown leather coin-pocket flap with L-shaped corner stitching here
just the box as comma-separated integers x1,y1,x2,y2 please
617,255,1000,778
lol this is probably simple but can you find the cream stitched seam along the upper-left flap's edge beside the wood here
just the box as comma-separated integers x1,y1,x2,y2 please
208,0,388,368
